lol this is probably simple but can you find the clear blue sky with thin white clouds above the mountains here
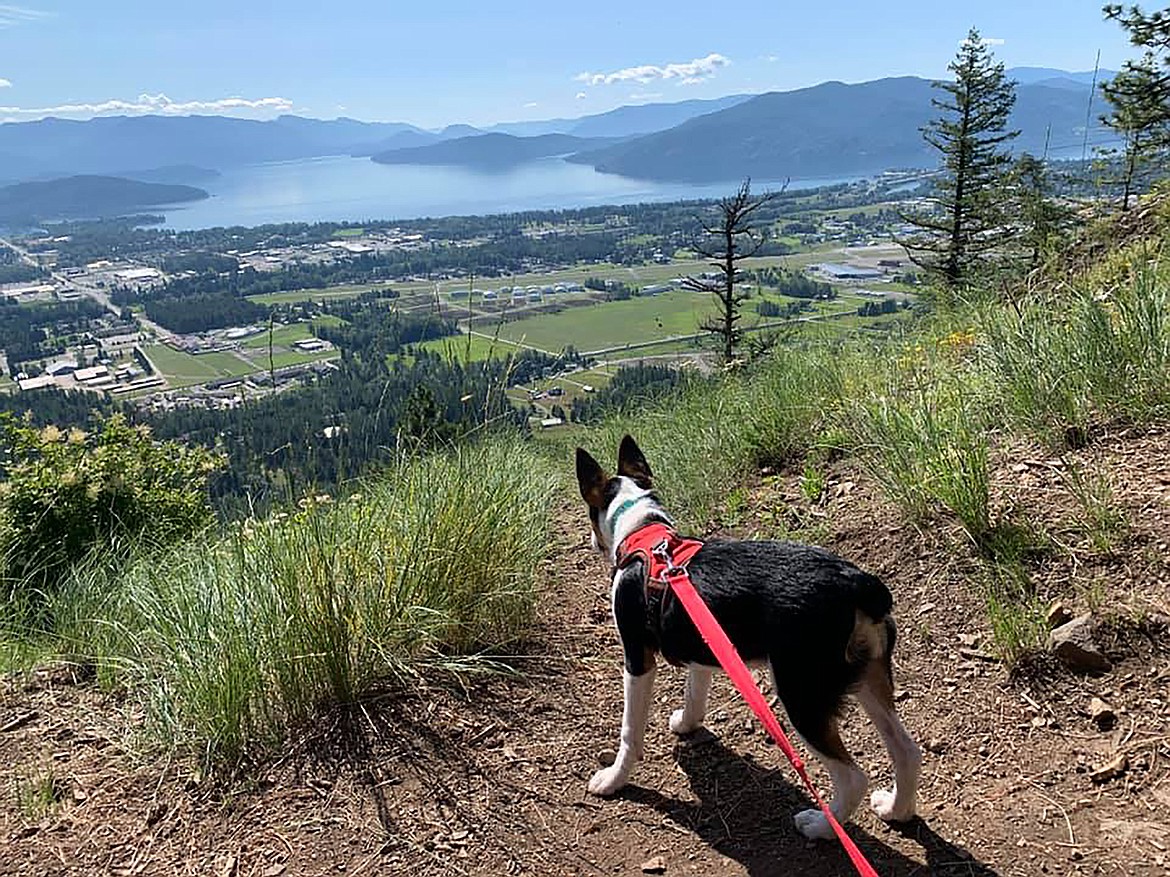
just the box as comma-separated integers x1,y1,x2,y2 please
0,0,1141,127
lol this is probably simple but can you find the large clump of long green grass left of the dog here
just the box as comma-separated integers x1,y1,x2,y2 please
44,440,557,762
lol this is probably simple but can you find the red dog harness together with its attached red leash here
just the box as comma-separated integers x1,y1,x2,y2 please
617,523,878,877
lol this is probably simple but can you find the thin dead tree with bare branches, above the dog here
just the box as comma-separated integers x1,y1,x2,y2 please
682,178,779,364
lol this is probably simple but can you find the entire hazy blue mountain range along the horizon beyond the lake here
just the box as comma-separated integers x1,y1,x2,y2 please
0,68,1113,191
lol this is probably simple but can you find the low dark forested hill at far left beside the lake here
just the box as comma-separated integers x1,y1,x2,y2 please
0,175,208,223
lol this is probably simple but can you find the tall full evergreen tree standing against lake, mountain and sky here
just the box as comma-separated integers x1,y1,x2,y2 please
902,28,1019,288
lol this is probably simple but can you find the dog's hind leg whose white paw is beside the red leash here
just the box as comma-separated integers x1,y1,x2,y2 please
772,669,869,840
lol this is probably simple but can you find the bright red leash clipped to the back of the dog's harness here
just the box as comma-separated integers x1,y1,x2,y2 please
654,539,878,877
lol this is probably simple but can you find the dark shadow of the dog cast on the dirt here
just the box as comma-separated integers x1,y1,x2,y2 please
621,731,999,877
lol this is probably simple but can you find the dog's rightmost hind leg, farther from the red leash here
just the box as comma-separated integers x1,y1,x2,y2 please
854,655,922,822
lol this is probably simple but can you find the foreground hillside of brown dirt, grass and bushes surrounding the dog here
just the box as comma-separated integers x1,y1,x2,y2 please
0,183,1170,877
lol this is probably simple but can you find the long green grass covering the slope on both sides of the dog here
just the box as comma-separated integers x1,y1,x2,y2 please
8,194,1170,767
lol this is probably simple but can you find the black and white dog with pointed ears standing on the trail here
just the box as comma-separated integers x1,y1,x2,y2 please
577,435,922,838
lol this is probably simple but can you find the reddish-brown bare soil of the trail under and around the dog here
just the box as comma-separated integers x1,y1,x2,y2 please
0,431,1170,877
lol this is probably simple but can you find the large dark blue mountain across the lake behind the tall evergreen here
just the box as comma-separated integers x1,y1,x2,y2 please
571,76,1100,182
